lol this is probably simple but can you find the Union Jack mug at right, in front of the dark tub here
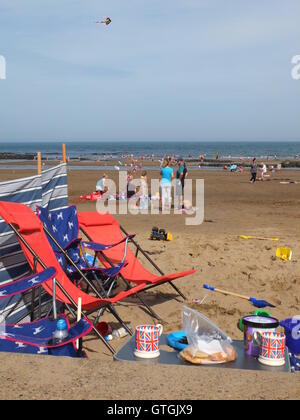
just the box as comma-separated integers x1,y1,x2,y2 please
256,332,286,366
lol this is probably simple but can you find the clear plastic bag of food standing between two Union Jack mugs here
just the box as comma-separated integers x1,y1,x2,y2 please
180,306,237,364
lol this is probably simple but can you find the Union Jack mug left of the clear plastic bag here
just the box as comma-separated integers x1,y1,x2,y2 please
134,324,163,359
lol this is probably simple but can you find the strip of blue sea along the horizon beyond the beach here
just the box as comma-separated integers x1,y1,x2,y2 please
0,141,300,160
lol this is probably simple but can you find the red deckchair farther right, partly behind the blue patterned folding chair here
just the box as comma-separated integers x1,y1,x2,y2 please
78,212,196,298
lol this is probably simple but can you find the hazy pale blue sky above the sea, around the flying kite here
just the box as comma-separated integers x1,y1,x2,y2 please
0,0,300,142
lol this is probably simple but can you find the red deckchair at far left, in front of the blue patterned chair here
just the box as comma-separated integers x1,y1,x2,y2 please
0,202,145,353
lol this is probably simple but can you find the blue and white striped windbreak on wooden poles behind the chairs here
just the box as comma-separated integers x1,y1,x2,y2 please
0,164,68,323
